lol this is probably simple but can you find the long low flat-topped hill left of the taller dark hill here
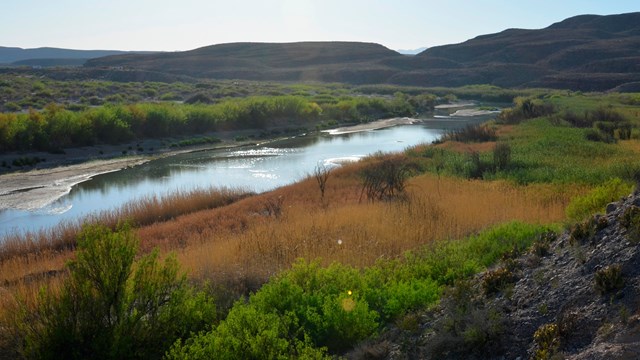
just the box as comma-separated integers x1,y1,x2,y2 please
86,42,404,83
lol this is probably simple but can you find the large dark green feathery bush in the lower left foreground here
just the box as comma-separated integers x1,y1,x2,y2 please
20,225,215,359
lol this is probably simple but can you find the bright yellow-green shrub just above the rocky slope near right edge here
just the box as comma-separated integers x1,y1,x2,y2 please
565,178,632,221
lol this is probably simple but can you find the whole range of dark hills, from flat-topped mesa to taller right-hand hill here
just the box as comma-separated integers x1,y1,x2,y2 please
86,13,640,91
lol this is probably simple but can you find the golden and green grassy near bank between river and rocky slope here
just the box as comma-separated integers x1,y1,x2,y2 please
0,90,640,358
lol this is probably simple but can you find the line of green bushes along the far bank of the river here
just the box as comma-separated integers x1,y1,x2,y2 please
0,95,433,152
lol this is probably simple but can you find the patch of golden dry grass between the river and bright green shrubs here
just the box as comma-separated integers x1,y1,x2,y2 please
179,175,579,282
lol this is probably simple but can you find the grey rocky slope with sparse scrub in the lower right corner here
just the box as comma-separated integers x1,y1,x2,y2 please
360,193,640,360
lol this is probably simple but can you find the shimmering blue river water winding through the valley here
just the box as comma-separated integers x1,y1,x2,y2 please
0,116,490,236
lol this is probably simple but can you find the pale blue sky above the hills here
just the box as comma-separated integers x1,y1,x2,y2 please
0,0,640,51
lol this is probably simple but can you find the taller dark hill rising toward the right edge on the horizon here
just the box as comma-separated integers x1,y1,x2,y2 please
390,13,640,90
